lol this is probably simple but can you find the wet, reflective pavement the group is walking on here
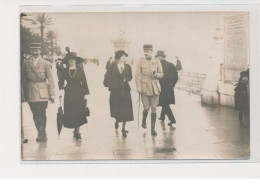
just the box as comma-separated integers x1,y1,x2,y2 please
22,64,250,160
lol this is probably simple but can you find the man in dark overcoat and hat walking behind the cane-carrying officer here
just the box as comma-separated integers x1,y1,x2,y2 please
156,51,178,126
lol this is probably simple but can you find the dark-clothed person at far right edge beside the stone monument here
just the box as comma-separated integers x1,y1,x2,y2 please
235,69,250,127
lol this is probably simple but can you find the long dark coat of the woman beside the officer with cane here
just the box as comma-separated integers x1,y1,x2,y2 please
104,64,134,122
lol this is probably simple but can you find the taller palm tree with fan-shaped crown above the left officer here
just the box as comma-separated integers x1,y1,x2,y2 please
30,13,53,43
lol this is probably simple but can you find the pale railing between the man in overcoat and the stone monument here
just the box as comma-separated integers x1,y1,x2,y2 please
175,72,206,95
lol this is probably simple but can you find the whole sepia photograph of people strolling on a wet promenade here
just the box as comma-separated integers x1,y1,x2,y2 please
19,11,250,161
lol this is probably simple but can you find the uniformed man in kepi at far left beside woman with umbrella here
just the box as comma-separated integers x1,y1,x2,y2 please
22,43,55,142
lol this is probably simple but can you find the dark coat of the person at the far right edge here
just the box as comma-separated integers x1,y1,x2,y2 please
235,82,249,111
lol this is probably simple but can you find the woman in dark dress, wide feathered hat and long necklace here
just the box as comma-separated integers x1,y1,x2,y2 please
59,52,89,139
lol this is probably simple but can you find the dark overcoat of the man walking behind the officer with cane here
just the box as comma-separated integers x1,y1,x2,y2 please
158,60,178,106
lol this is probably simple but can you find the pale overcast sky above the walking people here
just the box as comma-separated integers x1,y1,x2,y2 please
22,12,242,72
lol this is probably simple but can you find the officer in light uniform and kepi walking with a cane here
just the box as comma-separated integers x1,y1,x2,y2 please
136,45,163,136
